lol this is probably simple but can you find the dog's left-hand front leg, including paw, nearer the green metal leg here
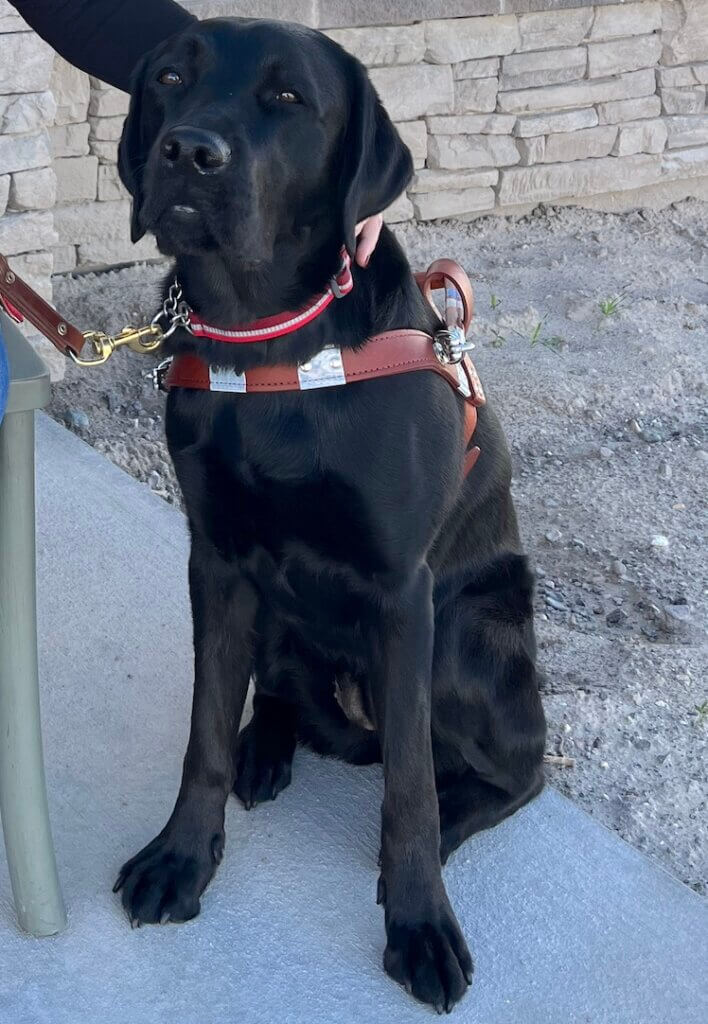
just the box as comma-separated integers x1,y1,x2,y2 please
114,540,257,924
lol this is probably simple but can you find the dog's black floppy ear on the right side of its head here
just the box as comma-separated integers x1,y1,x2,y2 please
340,57,413,256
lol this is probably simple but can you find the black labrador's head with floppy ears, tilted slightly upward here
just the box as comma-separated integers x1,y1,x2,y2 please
119,18,412,266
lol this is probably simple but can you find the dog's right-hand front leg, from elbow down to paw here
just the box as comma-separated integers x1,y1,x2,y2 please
373,565,472,1013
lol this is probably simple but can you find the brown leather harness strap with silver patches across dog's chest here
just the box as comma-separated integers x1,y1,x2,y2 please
164,329,485,475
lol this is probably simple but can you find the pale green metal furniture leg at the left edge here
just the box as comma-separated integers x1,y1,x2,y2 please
0,409,67,936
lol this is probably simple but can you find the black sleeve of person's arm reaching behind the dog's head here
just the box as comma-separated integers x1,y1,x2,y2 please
10,0,195,92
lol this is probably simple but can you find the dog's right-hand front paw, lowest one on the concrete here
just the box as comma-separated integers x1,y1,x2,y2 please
383,901,474,1014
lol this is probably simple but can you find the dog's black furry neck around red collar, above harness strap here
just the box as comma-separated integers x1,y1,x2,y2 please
166,227,432,372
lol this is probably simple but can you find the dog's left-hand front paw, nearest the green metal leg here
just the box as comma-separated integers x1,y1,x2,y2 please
113,833,223,927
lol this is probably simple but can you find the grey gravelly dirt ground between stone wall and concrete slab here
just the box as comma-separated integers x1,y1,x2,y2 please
50,202,708,894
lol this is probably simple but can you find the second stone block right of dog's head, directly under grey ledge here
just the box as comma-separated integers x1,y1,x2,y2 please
425,14,518,63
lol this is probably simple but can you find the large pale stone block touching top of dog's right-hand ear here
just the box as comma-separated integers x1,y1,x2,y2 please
371,65,454,121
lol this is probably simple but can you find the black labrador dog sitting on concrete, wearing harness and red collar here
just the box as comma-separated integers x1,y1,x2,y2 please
116,18,545,1011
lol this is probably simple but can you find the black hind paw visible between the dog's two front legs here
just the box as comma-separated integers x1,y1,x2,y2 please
234,692,297,810
